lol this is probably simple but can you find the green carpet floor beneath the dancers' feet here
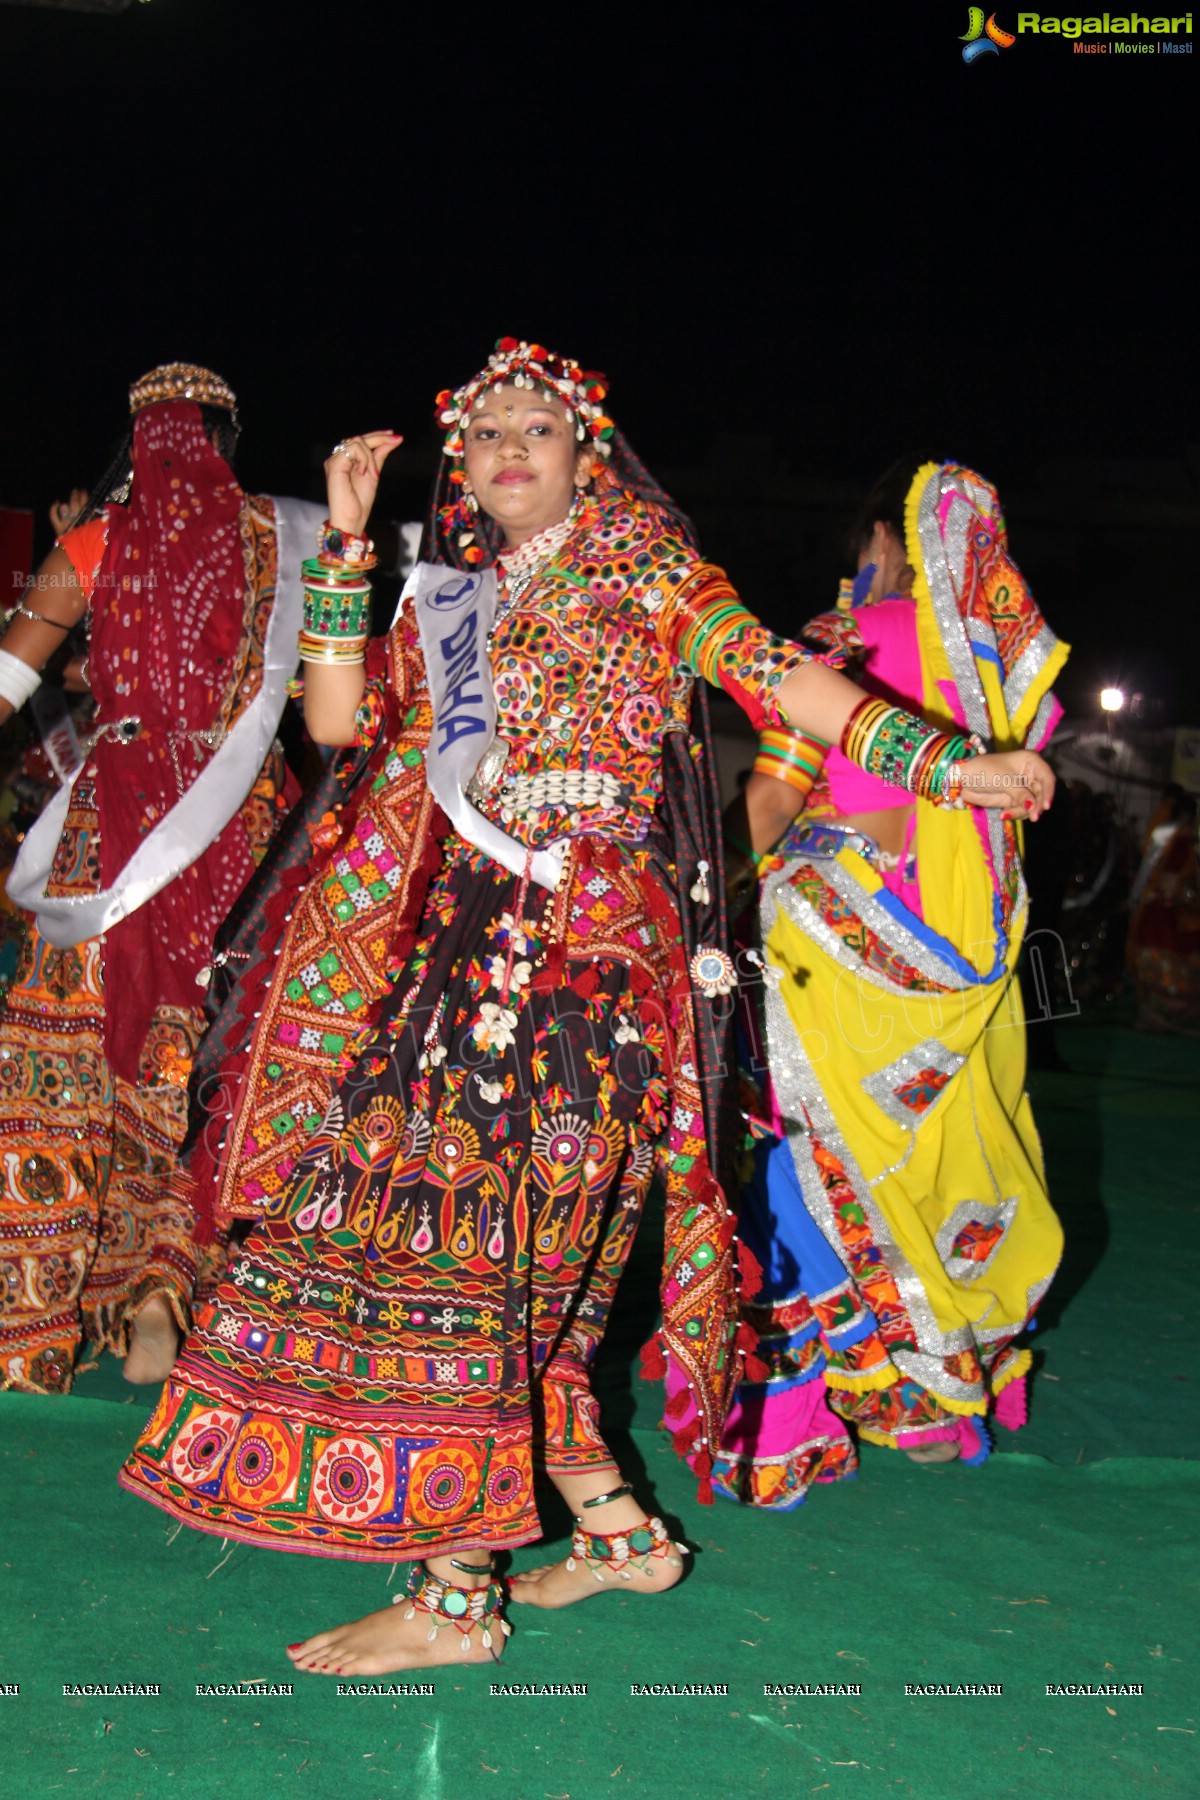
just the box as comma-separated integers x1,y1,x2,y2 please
0,1022,1200,1800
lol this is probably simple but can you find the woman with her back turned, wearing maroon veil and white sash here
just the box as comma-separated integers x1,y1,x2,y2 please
0,362,320,1393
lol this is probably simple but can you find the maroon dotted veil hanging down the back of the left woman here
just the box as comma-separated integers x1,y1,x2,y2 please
90,400,254,1082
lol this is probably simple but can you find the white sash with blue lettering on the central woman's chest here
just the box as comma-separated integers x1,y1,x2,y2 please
408,563,563,891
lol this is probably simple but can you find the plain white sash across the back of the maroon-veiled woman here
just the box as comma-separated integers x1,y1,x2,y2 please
9,499,326,950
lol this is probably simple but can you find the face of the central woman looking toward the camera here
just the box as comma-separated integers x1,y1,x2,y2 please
464,387,594,549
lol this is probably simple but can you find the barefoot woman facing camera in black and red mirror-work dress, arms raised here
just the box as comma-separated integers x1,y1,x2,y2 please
122,351,1052,1674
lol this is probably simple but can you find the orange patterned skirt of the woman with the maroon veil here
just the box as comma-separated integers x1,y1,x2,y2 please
0,920,203,1393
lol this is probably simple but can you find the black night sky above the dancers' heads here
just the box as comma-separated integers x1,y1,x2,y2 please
0,0,1200,722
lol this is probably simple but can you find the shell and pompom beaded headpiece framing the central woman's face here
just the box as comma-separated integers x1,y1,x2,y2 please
435,338,617,563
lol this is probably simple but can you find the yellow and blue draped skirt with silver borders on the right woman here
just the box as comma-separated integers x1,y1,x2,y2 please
716,831,1061,1507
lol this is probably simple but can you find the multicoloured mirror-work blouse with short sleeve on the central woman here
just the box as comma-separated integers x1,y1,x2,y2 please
367,493,806,844
